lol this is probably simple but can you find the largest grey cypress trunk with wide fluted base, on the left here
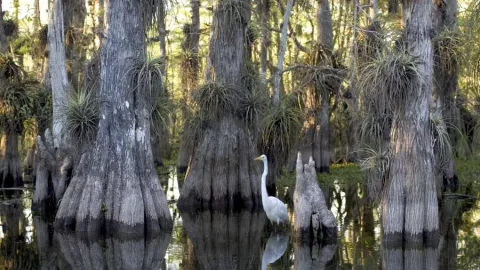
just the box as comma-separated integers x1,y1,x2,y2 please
55,0,172,235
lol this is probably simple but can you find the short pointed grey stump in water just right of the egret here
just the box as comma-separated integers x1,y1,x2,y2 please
293,152,337,242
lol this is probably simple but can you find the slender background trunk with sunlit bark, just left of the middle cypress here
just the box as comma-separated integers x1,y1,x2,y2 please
177,0,200,173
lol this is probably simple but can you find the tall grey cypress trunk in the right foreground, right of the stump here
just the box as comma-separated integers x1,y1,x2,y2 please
382,0,438,241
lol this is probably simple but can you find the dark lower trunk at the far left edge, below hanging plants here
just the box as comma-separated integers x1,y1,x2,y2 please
0,130,23,187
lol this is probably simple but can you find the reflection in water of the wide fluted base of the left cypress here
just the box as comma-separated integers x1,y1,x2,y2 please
54,229,171,269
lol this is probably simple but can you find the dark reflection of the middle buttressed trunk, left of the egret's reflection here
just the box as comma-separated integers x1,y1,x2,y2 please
180,211,265,269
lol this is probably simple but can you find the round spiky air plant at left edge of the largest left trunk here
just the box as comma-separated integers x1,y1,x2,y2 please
65,90,99,144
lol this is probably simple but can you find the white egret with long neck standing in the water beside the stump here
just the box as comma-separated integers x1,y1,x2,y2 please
255,155,288,224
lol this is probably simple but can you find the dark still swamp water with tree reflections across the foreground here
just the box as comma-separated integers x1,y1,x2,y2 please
0,168,480,269
